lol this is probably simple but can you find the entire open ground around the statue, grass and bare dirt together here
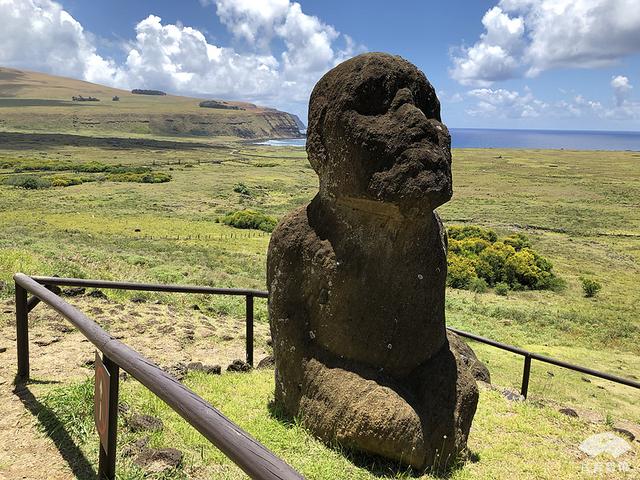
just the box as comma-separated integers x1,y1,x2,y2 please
0,125,640,479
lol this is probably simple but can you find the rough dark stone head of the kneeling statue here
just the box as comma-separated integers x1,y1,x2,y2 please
307,53,452,212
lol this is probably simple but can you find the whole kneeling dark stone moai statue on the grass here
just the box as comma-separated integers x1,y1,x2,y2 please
267,53,478,469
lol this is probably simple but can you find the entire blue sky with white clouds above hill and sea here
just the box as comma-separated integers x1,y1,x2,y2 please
0,0,640,131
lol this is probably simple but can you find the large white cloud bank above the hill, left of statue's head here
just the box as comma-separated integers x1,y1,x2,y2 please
0,0,362,115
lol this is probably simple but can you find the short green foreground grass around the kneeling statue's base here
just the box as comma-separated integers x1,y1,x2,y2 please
36,371,640,480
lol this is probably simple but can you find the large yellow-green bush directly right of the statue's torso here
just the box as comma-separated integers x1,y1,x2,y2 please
447,226,564,291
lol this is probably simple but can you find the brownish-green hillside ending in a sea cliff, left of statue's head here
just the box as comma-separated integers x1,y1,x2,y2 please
0,67,302,139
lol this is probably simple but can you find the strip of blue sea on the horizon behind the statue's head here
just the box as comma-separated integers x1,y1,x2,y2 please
255,128,640,151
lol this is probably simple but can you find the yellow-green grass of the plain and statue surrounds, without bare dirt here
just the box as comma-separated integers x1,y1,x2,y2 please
0,131,640,479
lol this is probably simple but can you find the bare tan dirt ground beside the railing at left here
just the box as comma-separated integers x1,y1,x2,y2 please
0,297,268,480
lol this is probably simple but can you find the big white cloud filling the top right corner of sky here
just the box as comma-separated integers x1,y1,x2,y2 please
450,0,640,86
